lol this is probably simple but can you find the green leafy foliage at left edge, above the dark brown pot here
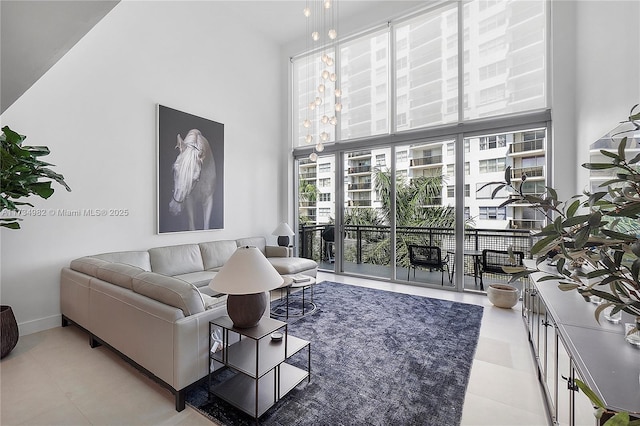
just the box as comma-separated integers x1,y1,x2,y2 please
0,126,71,229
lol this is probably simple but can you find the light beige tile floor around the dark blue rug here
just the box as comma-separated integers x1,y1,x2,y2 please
0,273,548,426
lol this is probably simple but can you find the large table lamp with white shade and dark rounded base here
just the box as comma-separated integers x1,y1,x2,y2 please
209,246,284,328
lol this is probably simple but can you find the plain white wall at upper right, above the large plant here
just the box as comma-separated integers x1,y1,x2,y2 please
575,0,640,192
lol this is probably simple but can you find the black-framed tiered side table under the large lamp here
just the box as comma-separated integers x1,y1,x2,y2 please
209,316,311,420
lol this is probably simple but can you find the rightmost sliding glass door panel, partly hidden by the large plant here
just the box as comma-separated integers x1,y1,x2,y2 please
464,128,548,291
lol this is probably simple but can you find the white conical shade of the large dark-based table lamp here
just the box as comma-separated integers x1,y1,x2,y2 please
209,246,284,294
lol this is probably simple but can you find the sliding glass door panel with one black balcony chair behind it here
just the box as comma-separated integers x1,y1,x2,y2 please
393,139,455,287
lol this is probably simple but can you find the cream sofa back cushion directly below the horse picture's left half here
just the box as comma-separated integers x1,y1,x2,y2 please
149,244,204,276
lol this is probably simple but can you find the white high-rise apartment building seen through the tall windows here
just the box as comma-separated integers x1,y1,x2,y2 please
294,1,548,229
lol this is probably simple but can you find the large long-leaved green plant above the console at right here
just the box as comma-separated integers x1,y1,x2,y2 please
485,105,640,426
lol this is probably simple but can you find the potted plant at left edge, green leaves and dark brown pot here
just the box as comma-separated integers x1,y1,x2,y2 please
0,126,71,358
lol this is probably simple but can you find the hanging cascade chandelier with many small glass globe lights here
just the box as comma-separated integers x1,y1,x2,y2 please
302,0,342,162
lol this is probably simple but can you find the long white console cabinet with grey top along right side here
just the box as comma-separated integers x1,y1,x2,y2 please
522,260,640,426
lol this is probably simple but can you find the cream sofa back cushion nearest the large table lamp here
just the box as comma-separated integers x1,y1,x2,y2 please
133,272,204,316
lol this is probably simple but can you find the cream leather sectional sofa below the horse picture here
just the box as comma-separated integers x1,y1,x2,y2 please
60,237,318,411
